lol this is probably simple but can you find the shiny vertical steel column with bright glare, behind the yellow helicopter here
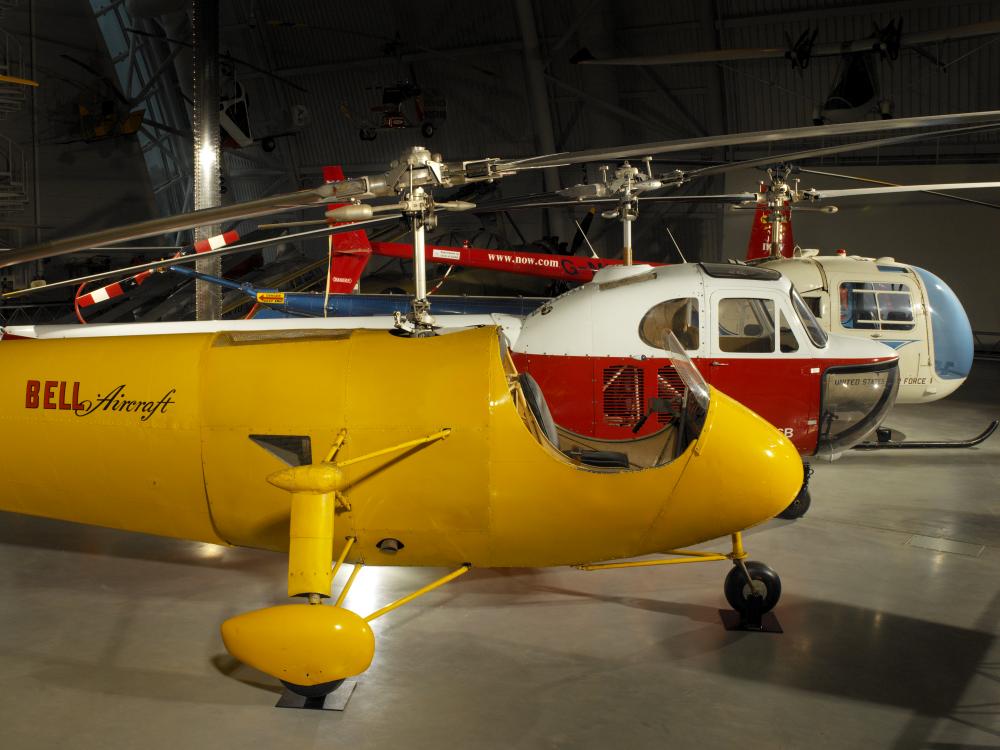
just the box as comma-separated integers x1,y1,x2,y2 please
191,0,222,320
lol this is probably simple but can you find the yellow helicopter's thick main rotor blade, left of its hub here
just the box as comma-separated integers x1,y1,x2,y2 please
0,183,341,268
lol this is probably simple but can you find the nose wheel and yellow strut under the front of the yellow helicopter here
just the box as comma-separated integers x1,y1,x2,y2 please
576,531,784,633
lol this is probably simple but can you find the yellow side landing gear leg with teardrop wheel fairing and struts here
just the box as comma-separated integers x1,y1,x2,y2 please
222,429,454,707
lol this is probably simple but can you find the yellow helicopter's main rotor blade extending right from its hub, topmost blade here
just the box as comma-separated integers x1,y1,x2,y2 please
499,110,1000,171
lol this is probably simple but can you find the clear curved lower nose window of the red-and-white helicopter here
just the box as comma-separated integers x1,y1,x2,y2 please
817,361,899,453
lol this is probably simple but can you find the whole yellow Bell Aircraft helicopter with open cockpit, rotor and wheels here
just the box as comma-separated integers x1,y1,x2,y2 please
0,112,1000,695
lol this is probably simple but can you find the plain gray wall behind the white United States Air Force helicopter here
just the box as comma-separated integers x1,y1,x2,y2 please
723,169,1000,331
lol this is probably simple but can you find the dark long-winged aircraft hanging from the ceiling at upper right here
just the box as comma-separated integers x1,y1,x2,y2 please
570,18,1000,125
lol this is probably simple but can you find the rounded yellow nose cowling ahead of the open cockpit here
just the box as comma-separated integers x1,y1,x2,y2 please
650,388,803,549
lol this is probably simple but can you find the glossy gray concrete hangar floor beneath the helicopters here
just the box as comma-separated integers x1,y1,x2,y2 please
0,362,1000,750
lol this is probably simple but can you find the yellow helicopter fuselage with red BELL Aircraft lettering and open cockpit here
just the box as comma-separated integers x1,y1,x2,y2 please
0,328,802,567
